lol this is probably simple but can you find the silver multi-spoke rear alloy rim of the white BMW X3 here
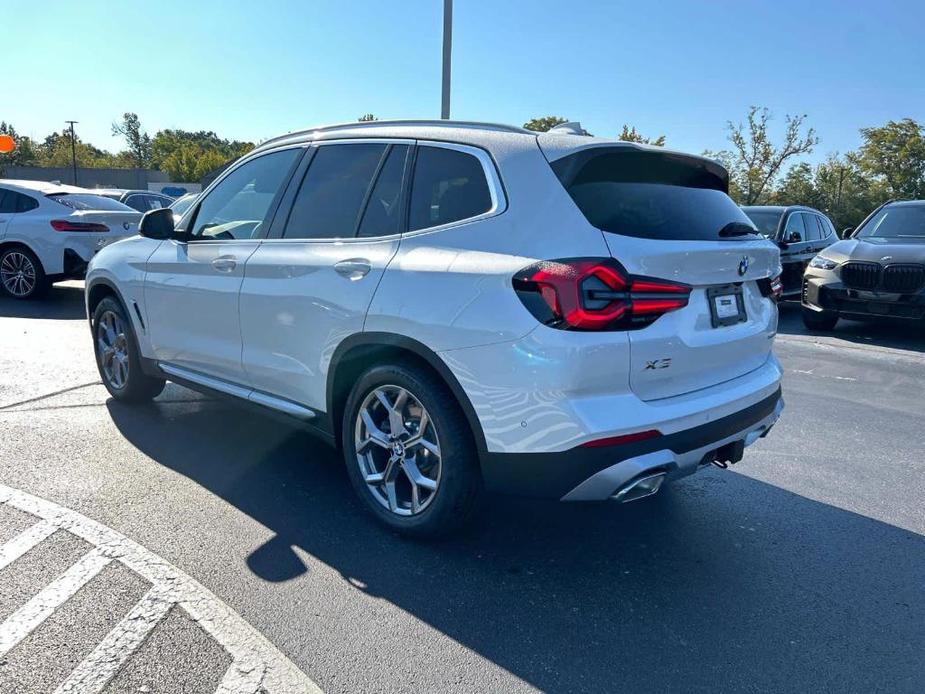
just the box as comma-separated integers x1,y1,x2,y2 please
354,385,442,516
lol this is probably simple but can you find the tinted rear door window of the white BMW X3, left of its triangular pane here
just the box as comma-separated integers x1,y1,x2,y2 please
283,143,386,239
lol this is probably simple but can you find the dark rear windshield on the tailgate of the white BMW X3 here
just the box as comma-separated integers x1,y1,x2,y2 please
552,148,757,241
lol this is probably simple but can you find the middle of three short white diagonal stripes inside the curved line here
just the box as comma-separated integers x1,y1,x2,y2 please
0,548,112,658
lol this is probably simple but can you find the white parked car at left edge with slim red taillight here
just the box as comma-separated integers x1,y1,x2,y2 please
0,180,141,299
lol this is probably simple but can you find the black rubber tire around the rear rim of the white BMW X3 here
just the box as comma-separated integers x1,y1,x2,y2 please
341,363,483,538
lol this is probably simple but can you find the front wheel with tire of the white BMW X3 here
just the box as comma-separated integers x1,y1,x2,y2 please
93,297,166,402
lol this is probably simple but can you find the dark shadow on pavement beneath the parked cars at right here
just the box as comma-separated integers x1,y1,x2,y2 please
777,301,925,352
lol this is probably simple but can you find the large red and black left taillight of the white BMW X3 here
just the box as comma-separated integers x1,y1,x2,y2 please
513,258,691,330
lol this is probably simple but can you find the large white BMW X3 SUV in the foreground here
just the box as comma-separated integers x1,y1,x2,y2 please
86,121,783,535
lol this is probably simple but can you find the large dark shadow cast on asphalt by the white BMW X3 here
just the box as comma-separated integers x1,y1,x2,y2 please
108,386,925,691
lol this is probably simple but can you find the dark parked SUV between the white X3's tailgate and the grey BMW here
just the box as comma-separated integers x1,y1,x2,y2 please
742,205,838,298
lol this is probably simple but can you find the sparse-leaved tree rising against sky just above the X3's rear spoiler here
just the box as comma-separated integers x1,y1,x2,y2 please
705,106,819,205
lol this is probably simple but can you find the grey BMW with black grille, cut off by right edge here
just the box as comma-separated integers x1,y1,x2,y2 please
802,200,925,330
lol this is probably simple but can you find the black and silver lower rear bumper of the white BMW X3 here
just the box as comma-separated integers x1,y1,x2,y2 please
482,388,784,501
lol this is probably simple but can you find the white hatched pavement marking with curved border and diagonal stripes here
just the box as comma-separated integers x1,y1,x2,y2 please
0,485,321,694
